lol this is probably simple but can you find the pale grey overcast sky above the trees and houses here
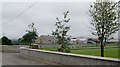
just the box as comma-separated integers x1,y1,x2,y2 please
0,1,118,39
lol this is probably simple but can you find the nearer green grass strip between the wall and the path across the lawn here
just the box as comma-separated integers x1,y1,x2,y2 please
71,48,120,58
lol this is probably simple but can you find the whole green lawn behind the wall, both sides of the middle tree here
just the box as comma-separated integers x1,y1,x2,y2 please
42,46,120,58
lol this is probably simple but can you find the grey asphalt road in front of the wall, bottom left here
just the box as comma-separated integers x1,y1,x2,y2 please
2,53,56,65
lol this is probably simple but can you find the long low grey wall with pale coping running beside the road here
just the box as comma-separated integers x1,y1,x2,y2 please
20,47,120,65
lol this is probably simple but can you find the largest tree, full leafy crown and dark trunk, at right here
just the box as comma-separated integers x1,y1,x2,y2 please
89,0,120,57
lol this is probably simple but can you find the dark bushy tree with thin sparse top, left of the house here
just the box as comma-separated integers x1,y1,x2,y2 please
18,23,38,45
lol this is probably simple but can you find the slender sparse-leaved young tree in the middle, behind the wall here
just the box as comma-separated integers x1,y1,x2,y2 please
52,11,70,52
